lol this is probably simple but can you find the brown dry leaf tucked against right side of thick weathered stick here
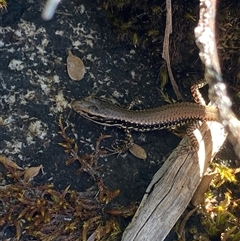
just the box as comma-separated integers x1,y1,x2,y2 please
191,171,218,206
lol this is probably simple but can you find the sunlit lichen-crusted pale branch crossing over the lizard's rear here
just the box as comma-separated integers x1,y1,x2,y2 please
195,0,240,157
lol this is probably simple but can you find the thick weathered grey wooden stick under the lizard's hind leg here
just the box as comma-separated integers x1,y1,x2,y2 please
122,122,226,241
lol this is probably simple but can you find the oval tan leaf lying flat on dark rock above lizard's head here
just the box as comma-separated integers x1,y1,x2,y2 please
67,51,86,80
